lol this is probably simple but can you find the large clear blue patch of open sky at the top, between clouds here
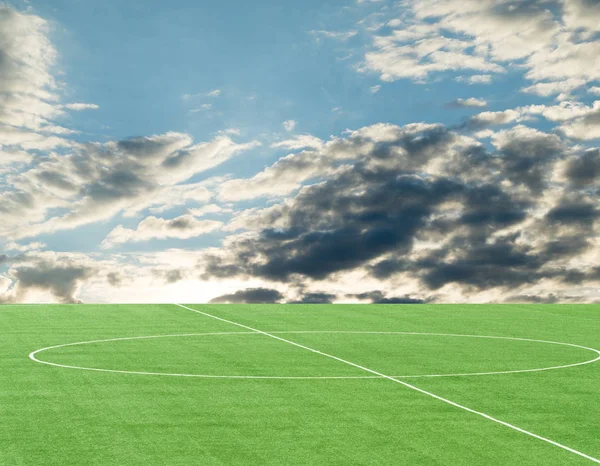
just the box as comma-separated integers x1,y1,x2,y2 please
31,0,540,144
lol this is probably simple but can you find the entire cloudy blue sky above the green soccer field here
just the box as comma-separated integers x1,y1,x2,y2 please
0,0,600,303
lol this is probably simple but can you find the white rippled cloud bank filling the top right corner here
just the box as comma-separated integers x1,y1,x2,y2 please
361,0,600,99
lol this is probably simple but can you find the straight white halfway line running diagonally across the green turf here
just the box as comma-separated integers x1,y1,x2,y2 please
176,304,600,464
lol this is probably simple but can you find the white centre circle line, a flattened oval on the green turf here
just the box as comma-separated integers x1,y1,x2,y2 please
29,330,600,380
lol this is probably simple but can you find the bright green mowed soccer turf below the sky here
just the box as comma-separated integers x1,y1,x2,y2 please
0,305,600,466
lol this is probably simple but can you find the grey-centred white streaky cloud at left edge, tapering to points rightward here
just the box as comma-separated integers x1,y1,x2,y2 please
0,133,258,239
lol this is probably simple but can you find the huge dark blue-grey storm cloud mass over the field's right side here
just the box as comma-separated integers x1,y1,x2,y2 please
204,121,598,303
